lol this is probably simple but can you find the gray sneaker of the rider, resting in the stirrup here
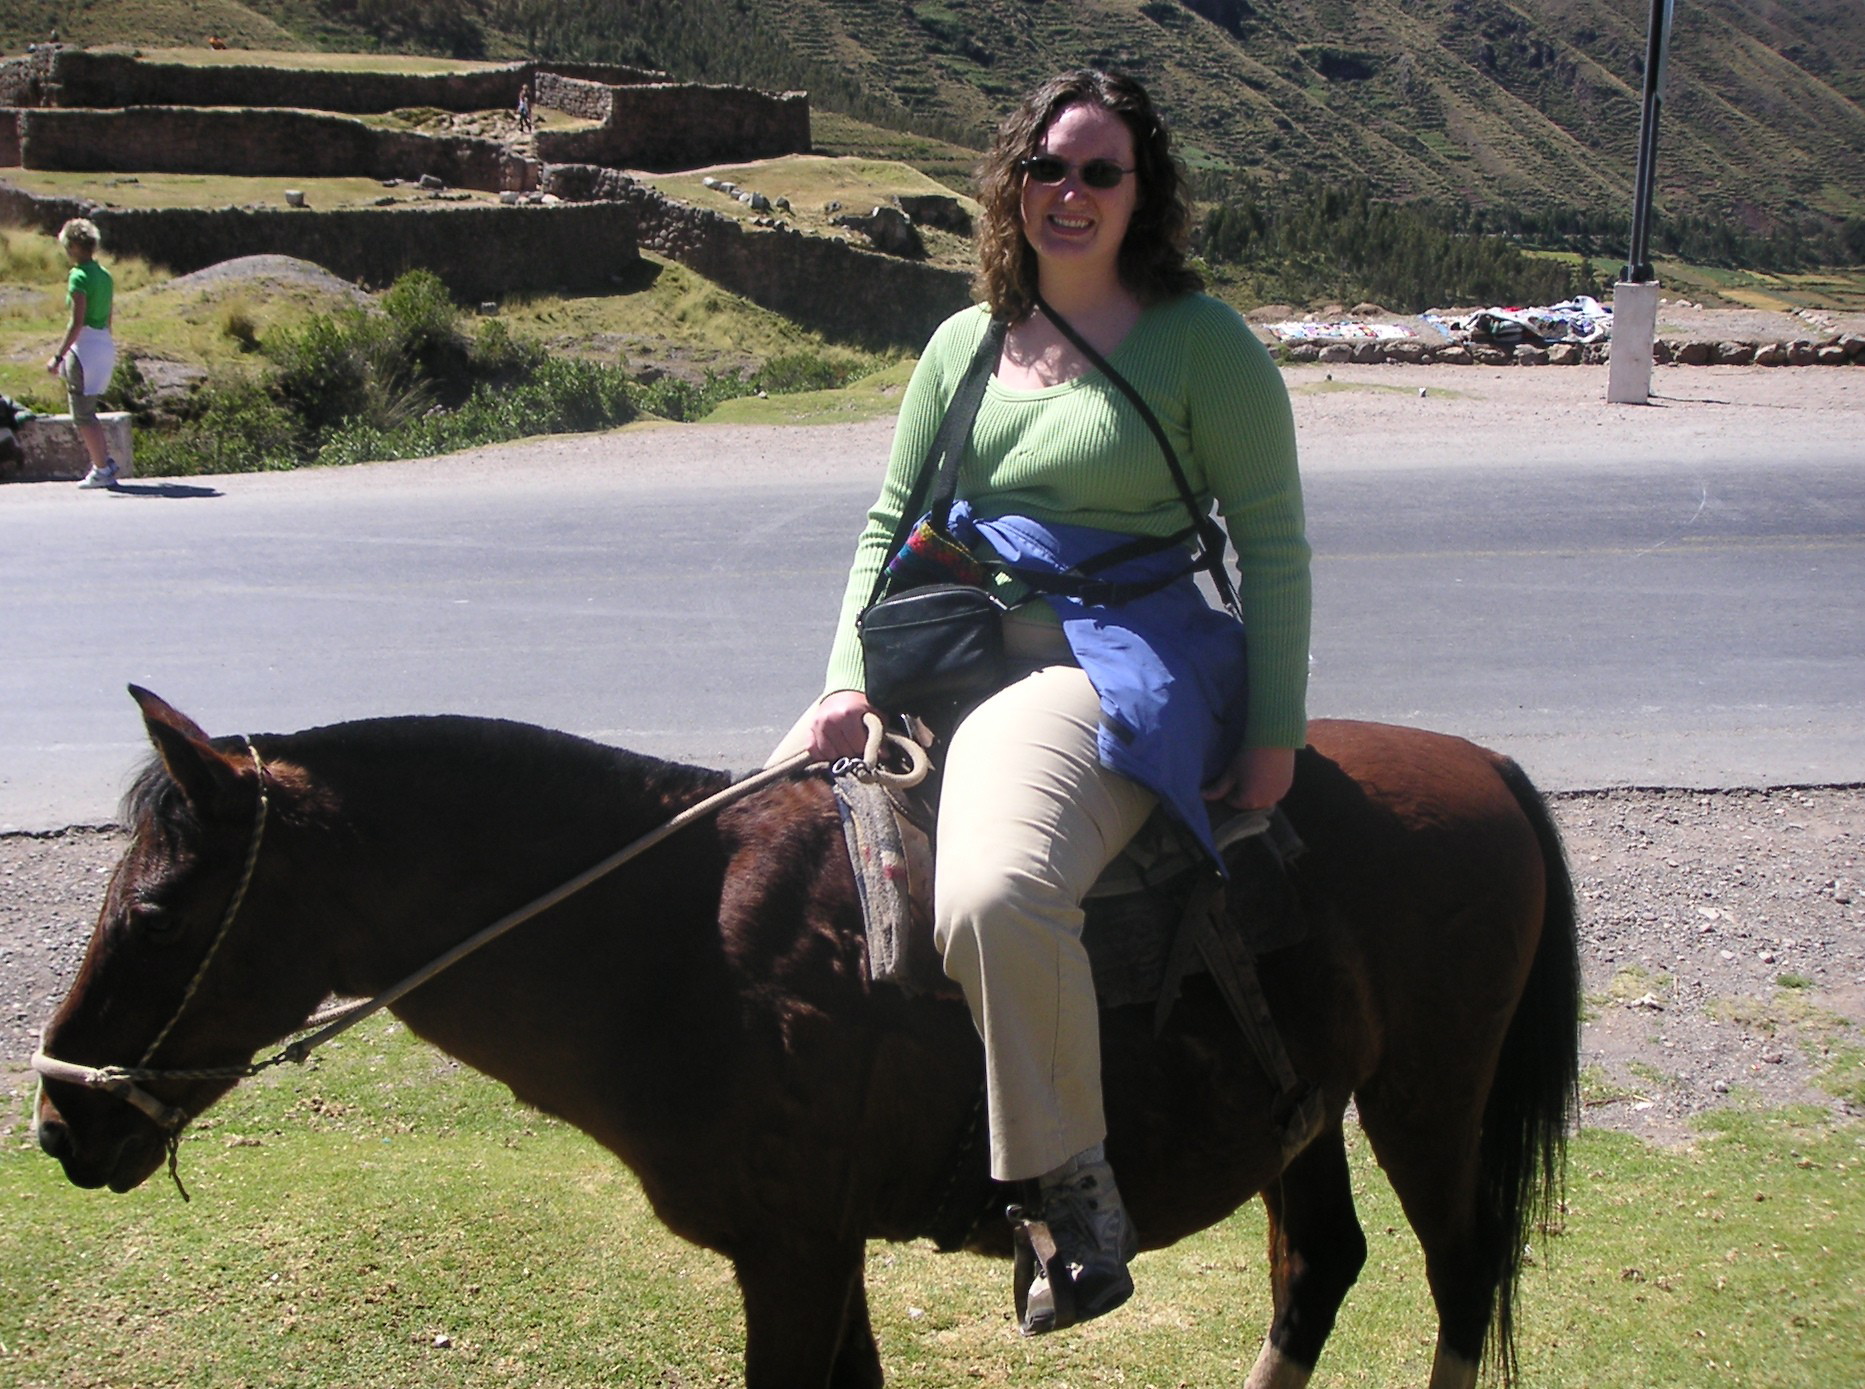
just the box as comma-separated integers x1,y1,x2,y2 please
1005,1145,1140,1337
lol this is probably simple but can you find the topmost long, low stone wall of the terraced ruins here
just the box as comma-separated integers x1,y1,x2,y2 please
0,47,666,116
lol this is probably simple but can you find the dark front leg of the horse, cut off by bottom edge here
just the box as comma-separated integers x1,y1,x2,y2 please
733,1240,880,1389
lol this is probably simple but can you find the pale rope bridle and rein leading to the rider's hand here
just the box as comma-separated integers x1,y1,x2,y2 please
32,714,929,1201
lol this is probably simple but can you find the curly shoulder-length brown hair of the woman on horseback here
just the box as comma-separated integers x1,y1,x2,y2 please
977,67,1205,323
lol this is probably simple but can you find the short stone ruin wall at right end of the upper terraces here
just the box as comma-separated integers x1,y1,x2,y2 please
535,84,809,170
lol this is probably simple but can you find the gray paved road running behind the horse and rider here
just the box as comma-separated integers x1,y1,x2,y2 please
0,406,1865,830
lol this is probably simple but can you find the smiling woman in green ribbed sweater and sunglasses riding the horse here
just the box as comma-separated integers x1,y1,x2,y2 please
774,71,1311,1335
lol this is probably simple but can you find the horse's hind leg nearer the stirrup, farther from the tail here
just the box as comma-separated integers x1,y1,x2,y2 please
1244,1115,1367,1389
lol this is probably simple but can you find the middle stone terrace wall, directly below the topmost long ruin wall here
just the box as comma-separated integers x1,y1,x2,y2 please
16,106,535,192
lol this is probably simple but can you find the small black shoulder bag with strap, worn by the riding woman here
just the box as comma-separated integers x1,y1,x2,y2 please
856,319,1007,727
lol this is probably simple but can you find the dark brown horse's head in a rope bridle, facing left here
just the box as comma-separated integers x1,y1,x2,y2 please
35,686,335,1191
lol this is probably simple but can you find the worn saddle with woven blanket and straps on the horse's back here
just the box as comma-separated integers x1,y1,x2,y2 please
830,759,1324,1249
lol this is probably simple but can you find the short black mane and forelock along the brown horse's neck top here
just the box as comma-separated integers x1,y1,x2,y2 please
117,714,729,833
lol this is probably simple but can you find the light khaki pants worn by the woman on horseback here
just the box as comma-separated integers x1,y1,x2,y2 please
772,613,1158,1182
